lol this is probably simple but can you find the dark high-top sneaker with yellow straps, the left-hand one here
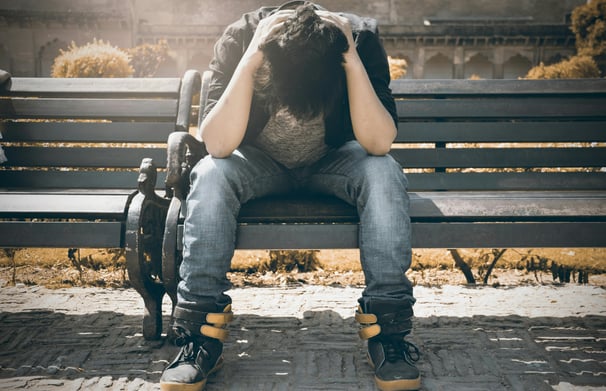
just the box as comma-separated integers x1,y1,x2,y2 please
160,304,233,391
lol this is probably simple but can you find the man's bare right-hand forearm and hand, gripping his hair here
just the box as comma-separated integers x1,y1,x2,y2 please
318,11,397,155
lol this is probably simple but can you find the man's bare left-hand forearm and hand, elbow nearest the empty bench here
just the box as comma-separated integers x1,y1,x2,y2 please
200,12,290,158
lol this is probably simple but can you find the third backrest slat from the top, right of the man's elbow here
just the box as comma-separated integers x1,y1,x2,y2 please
396,121,606,143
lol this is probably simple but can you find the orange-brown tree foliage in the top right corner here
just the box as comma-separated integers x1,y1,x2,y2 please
570,0,606,57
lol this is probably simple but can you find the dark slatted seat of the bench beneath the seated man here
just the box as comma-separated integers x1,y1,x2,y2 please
204,191,606,249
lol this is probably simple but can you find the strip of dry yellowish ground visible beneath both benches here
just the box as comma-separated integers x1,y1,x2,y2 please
0,249,606,288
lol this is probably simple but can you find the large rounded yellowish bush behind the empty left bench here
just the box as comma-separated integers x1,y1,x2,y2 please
51,39,133,77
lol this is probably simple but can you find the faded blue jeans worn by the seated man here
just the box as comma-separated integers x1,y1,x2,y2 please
178,141,414,306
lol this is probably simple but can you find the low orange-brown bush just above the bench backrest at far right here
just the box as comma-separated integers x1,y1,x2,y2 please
525,56,600,79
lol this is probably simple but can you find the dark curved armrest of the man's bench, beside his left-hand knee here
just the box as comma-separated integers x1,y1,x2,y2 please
166,132,207,200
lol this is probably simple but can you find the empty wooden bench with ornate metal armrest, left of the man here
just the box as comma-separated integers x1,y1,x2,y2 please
0,71,200,340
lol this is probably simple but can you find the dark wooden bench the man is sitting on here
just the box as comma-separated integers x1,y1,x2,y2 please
132,73,606,340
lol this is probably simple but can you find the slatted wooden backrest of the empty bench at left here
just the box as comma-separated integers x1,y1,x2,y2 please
0,71,200,193
